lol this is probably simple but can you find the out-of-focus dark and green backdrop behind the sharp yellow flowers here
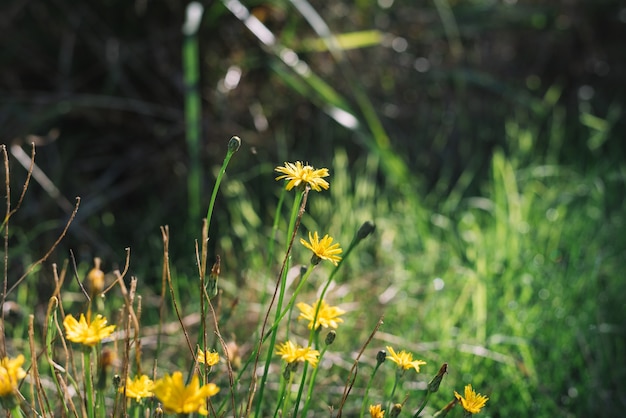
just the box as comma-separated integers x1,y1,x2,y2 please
0,0,626,417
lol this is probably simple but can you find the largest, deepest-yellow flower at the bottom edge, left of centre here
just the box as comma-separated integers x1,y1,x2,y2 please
153,372,220,415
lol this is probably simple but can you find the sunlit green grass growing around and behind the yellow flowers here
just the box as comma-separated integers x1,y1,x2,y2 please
3,109,624,416
